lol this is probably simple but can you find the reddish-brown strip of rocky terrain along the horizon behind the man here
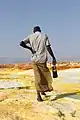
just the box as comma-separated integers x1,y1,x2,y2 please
0,62,80,70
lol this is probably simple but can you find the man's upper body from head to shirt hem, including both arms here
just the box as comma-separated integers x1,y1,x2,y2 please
20,26,56,64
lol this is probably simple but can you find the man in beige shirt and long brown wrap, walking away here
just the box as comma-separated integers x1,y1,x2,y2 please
20,26,56,101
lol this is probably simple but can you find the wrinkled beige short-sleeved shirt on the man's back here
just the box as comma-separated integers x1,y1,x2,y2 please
23,32,50,63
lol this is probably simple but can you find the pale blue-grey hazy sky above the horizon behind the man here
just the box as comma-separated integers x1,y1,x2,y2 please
0,0,80,59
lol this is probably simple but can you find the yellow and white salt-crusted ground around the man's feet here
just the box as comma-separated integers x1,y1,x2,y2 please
0,68,80,120
